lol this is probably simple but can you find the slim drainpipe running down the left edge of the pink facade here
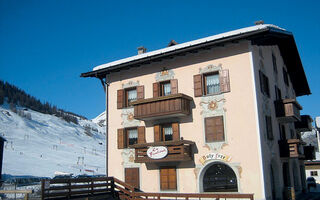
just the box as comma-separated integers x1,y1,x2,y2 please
99,78,110,177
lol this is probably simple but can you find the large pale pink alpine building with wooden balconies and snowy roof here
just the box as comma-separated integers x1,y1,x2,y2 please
81,24,310,199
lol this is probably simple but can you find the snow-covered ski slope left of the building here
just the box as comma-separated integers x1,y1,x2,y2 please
0,105,105,177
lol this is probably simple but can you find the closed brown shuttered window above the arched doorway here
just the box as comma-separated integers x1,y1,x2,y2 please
205,116,224,142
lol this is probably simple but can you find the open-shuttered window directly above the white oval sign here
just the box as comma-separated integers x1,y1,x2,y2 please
154,123,180,142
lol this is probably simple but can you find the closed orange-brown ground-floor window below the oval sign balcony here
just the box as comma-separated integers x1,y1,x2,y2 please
160,167,177,190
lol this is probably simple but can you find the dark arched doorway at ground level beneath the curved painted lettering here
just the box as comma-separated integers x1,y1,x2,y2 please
202,162,238,192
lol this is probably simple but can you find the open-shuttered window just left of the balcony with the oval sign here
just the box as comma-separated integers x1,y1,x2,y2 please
117,126,146,149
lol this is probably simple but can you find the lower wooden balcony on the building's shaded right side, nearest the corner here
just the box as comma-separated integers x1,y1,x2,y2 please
279,139,304,158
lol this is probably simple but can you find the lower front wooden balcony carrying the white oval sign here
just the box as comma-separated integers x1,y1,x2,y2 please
130,140,194,163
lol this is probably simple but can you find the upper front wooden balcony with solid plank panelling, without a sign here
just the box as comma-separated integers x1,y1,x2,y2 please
132,94,192,120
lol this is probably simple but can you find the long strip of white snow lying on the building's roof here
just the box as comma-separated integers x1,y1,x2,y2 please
92,24,291,71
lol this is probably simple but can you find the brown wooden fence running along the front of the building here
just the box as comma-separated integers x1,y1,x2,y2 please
41,177,253,200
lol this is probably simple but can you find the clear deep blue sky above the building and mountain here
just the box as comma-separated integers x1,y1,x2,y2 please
0,0,320,118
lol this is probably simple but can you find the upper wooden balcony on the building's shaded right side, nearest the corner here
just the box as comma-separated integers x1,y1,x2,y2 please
274,99,302,123
